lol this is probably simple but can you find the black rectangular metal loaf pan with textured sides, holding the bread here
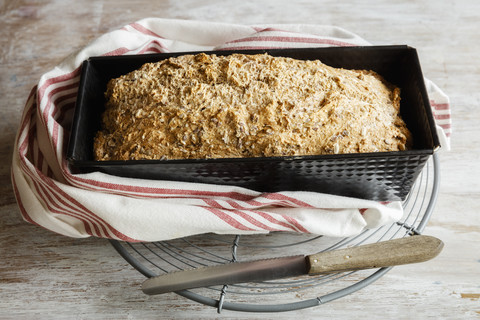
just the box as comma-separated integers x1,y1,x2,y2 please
67,46,440,201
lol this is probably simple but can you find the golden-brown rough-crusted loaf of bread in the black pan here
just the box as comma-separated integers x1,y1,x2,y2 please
94,54,412,160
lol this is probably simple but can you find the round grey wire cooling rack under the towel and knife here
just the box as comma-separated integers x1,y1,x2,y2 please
111,155,439,312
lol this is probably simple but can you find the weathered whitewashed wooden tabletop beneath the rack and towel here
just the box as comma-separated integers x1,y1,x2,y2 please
0,0,480,319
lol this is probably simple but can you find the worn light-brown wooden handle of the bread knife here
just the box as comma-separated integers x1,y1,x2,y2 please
306,235,443,274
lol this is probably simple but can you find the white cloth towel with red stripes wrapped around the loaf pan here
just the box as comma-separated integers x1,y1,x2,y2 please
12,18,450,241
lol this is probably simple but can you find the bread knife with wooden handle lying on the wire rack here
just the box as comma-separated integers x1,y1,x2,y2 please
142,235,443,295
